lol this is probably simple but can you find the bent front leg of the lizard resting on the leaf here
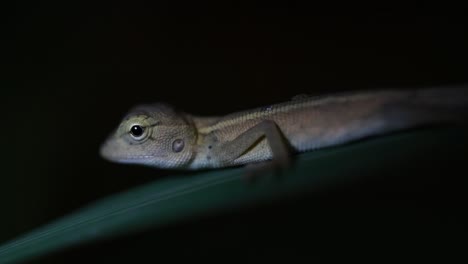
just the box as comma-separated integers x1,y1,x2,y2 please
213,120,291,168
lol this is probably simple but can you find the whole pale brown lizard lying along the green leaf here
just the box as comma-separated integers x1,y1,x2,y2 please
100,86,468,170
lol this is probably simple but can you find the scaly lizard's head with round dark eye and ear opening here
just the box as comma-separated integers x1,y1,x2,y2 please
100,104,197,168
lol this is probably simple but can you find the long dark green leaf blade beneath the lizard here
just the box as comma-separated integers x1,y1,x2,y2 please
0,128,468,262
